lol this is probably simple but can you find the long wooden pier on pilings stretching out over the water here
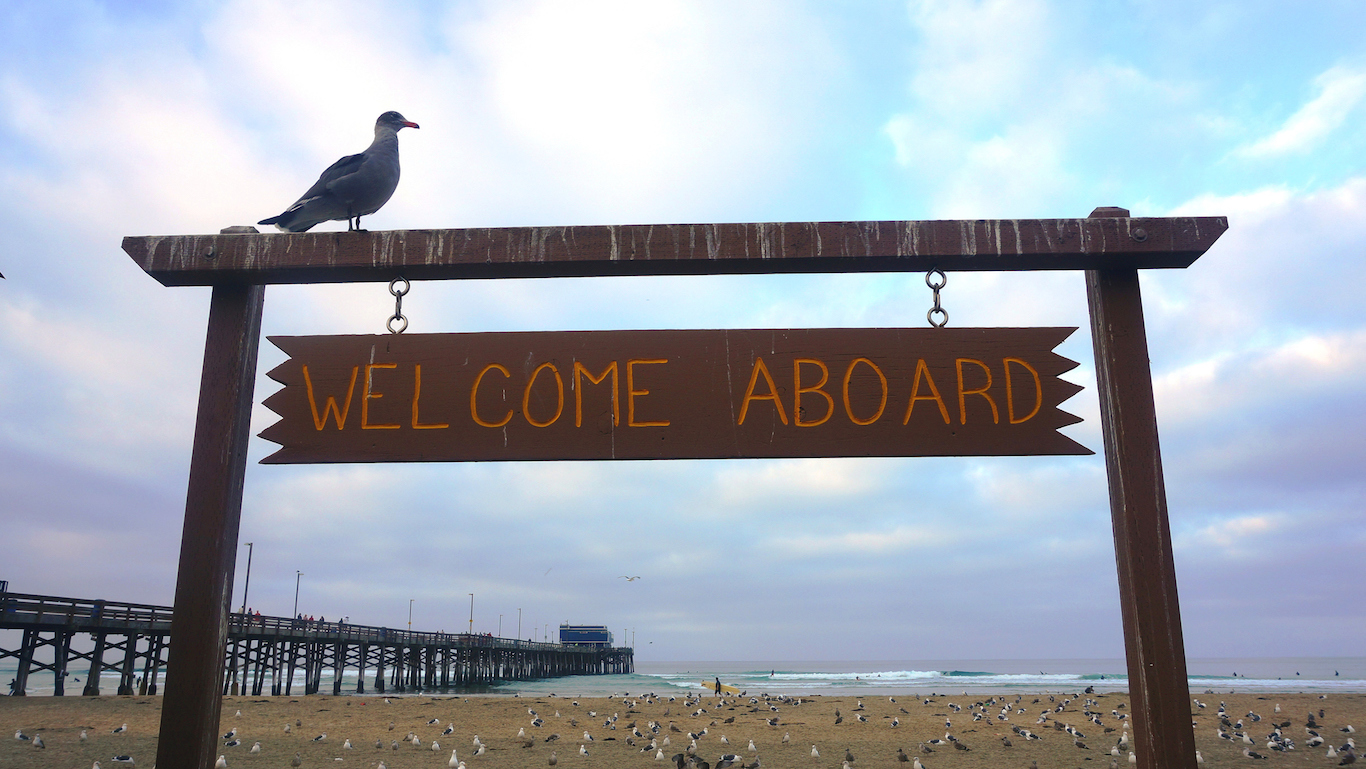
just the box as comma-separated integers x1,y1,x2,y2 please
0,593,635,697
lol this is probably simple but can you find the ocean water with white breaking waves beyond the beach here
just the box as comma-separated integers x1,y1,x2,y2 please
0,657,1366,697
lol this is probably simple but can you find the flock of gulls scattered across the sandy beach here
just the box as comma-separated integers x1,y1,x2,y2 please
14,690,1356,769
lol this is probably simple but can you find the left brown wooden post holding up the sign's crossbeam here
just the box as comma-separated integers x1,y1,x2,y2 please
156,284,265,769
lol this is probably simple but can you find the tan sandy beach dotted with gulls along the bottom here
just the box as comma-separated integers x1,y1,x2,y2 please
0,693,1366,769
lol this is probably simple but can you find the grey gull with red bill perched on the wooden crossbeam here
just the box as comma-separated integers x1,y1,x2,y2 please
257,111,418,232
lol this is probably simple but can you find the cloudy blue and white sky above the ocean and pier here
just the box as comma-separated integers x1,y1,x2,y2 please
0,0,1366,661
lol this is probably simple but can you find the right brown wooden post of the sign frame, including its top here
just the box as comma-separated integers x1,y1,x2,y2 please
1086,209,1195,769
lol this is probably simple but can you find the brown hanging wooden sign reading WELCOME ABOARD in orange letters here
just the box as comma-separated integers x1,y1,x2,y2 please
261,328,1093,463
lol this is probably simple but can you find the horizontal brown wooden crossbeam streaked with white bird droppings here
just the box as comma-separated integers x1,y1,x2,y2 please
123,216,1228,285
